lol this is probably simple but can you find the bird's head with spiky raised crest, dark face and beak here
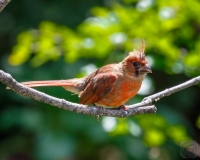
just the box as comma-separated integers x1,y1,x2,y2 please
121,41,152,77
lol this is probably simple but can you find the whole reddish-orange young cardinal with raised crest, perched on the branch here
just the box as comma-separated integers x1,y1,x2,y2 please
22,42,152,110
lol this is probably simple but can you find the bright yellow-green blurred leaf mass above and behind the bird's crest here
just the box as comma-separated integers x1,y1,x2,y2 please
9,1,200,75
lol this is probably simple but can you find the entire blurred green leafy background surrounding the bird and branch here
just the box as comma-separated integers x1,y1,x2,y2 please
0,0,200,160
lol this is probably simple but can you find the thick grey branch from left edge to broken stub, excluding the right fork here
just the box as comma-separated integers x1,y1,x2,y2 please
0,70,156,117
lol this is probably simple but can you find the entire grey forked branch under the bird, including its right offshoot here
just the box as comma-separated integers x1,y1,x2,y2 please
0,70,200,118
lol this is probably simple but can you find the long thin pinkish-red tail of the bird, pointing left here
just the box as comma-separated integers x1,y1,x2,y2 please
21,78,84,94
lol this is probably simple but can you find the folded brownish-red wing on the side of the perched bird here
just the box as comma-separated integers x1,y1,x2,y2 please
80,73,117,105
